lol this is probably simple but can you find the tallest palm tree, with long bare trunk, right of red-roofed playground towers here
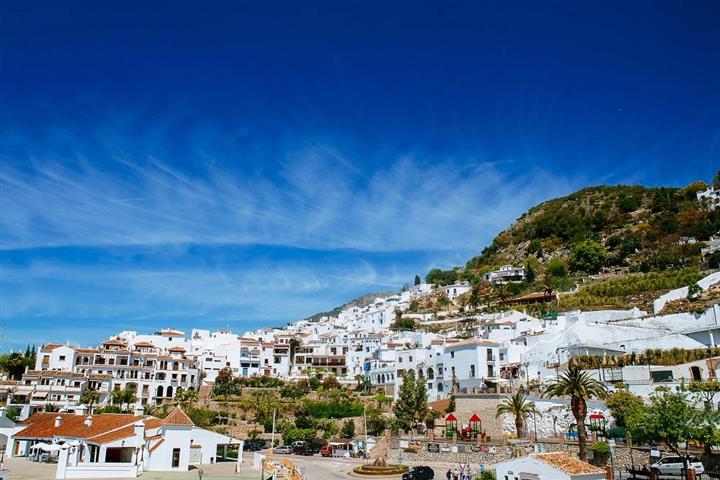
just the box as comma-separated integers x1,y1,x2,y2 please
543,365,607,461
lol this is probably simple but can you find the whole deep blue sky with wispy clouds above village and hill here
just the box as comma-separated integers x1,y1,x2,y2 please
0,1,720,349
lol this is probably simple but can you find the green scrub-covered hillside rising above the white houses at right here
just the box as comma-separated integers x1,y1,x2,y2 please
426,176,720,309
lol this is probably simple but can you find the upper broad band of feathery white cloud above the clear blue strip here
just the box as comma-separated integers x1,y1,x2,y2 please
0,122,577,251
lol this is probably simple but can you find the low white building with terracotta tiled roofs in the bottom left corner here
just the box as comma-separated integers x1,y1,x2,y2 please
7,407,243,479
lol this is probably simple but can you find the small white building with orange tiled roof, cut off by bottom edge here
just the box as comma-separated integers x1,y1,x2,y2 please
495,452,605,480
